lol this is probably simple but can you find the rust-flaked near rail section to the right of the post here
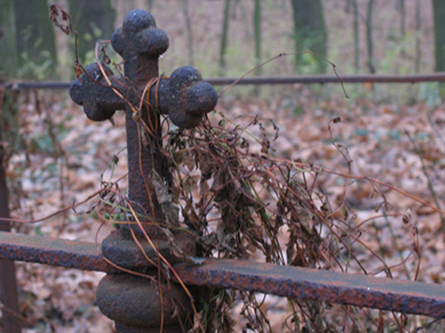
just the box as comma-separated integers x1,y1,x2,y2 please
175,259,445,318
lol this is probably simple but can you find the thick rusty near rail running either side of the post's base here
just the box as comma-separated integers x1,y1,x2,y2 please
0,232,445,318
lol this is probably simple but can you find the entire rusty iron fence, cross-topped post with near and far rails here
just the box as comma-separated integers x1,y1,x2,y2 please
0,6,445,332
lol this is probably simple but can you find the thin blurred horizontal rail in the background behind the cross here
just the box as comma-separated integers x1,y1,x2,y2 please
4,73,445,90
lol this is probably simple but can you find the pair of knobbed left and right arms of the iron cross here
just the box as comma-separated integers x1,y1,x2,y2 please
70,63,218,128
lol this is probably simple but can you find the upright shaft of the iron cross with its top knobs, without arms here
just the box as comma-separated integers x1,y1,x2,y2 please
111,10,169,221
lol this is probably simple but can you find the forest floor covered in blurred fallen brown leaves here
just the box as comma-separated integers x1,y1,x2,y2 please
3,81,445,333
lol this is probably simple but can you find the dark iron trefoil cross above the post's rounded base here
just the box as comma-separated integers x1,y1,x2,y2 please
70,10,218,232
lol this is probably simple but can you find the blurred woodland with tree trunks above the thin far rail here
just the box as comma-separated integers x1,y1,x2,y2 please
0,0,445,81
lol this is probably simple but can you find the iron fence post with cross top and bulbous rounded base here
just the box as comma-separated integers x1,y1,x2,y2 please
70,10,217,332
